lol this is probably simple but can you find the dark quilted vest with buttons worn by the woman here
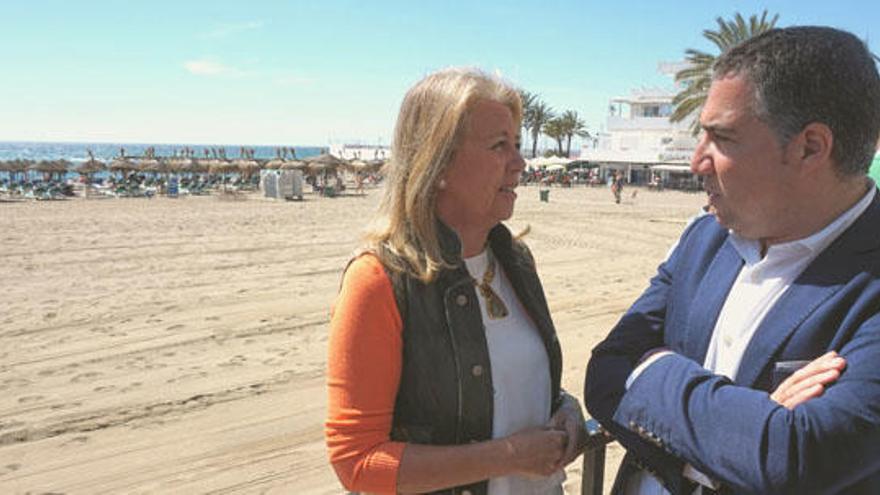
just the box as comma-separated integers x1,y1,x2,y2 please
389,222,562,495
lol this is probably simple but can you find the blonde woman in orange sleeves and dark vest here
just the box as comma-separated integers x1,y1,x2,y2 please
326,69,583,495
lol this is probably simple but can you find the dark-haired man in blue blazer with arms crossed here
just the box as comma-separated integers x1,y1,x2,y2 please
585,27,880,494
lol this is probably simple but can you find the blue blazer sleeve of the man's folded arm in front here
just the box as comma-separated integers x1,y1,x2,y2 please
614,315,880,493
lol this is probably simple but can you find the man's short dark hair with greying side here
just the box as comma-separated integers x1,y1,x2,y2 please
714,26,880,175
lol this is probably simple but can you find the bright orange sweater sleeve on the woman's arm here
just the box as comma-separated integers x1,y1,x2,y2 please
324,255,404,493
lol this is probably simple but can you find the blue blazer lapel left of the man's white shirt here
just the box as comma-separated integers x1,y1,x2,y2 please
683,237,743,365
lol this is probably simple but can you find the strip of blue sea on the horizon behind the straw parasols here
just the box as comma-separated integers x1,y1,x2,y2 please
0,141,327,179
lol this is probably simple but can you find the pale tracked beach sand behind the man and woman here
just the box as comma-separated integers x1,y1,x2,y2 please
0,187,704,494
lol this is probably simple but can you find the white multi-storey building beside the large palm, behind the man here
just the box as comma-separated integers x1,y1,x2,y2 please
579,64,698,187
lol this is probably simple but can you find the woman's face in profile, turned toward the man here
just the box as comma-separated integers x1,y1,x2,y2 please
437,100,525,235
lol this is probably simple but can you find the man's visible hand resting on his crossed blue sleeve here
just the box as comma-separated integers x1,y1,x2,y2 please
770,351,846,409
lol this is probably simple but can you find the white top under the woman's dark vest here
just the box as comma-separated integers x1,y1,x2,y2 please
464,250,565,495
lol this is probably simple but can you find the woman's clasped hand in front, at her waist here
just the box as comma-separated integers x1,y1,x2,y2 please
504,427,567,478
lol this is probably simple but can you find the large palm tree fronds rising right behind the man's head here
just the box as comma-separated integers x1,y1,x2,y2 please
669,10,779,135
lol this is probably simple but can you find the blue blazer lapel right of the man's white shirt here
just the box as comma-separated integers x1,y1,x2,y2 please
735,193,880,386
